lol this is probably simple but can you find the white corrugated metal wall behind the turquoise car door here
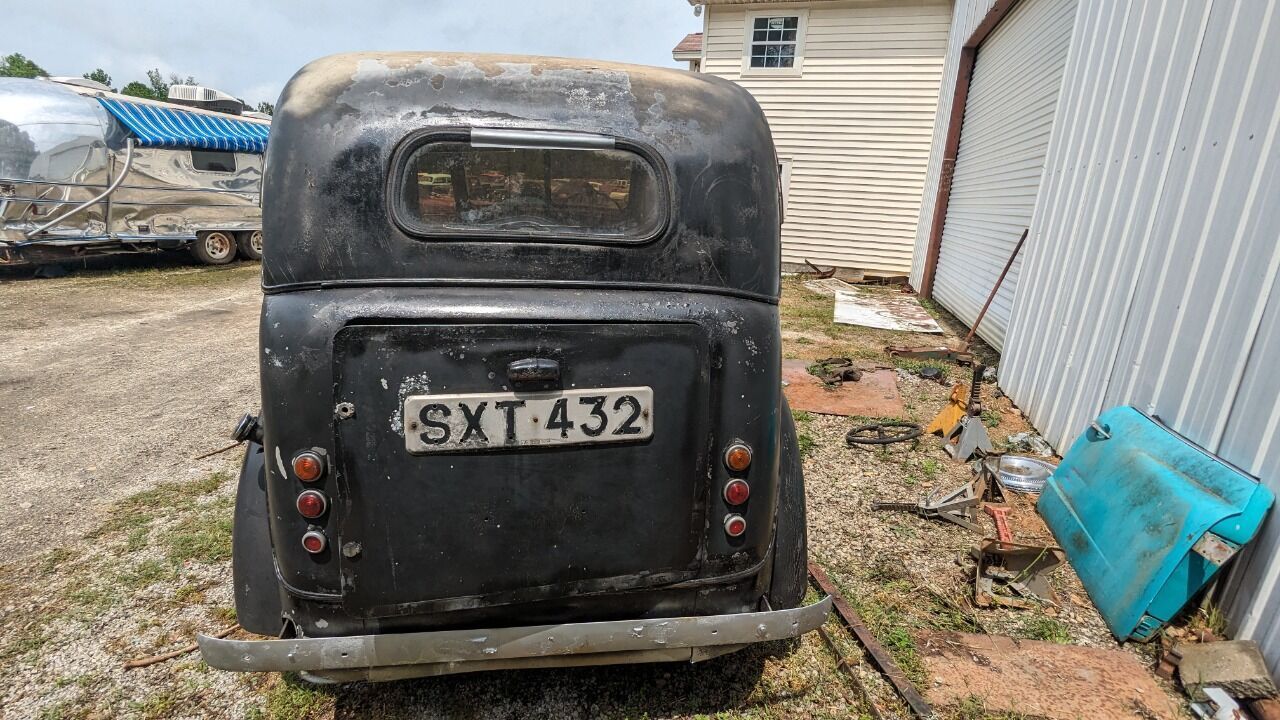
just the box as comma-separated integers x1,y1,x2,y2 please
1001,0,1280,675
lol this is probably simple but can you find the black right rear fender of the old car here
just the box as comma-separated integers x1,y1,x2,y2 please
768,398,809,610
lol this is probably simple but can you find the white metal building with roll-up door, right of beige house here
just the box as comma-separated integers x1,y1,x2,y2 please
911,0,1280,678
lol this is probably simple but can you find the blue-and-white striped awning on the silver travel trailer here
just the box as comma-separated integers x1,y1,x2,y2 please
97,97,271,152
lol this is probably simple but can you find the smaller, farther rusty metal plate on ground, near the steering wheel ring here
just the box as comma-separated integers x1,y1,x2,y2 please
782,360,904,418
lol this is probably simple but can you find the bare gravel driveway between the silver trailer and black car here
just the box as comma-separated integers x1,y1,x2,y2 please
0,256,261,560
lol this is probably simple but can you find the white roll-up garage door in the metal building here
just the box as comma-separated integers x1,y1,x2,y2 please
933,0,1075,350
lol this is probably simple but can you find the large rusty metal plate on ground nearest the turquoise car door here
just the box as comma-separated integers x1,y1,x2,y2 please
919,633,1179,720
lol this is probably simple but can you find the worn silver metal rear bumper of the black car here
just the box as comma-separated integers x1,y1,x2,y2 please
196,597,831,682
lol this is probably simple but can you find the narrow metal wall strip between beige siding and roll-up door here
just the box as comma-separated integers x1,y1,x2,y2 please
911,0,996,287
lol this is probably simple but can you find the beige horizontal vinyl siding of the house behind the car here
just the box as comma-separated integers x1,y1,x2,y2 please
703,0,951,274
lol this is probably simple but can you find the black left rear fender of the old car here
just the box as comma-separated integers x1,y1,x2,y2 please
232,441,283,635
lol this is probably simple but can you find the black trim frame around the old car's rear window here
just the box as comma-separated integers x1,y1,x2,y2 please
384,127,675,247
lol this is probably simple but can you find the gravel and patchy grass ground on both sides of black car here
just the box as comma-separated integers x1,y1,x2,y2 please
0,259,1198,720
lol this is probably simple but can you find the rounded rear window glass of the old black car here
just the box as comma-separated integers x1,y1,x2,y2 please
399,141,666,242
